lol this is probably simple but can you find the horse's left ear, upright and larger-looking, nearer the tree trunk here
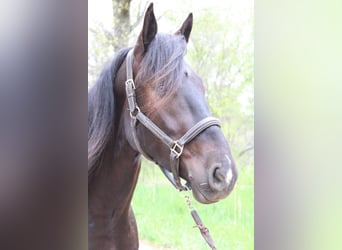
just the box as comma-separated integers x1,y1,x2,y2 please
134,3,158,59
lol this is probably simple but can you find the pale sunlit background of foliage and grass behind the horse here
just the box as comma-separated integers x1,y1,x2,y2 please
88,0,254,249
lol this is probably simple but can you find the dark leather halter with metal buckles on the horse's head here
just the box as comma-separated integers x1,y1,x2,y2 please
126,49,220,191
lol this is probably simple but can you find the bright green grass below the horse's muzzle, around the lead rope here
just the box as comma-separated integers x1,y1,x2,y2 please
133,162,254,250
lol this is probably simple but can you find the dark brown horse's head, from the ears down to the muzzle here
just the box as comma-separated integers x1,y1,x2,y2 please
126,4,237,203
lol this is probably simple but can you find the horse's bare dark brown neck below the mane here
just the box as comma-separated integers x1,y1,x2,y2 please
88,129,140,250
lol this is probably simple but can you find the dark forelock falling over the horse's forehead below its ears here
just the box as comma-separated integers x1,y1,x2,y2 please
136,33,186,115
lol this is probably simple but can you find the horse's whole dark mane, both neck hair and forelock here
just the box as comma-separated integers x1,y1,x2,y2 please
88,34,186,178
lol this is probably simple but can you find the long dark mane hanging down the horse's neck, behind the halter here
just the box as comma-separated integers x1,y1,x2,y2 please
88,48,130,177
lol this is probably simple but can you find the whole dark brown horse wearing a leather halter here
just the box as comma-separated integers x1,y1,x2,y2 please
88,4,237,250
